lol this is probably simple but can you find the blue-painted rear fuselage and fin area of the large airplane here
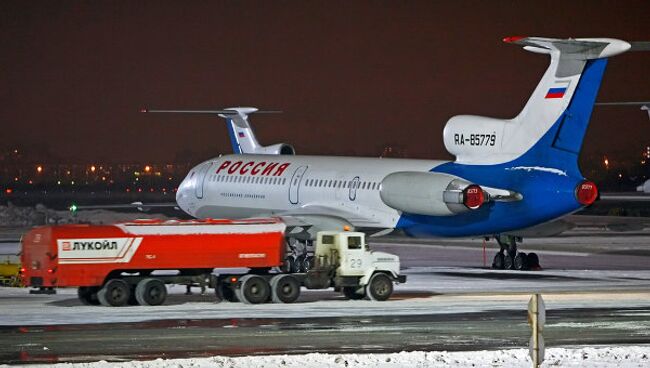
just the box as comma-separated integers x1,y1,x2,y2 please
396,59,607,237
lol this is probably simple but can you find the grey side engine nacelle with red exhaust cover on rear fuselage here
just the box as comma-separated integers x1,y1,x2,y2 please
379,171,488,216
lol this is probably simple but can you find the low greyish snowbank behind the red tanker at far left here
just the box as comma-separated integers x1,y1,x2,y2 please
0,203,167,227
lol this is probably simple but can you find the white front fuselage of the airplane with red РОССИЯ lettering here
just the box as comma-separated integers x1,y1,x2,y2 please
176,154,445,228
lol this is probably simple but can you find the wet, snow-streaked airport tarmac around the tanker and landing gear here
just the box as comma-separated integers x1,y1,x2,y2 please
0,230,650,364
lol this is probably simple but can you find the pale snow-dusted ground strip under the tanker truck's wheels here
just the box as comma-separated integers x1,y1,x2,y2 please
0,268,650,329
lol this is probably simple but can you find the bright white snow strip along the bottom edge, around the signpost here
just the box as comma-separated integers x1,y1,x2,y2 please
13,346,650,368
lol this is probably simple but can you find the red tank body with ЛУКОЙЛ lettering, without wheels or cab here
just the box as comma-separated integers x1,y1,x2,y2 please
21,219,285,288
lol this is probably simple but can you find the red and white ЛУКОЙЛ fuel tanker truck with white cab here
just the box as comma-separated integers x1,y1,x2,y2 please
21,218,406,307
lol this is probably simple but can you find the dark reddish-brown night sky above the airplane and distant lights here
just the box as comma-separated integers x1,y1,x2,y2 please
0,0,650,162
